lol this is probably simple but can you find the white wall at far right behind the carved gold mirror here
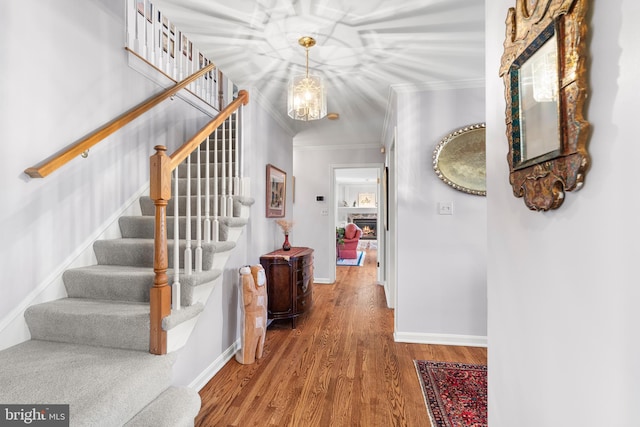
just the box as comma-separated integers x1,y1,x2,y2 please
486,0,640,427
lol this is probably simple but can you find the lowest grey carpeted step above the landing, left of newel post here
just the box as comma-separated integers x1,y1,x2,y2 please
24,298,149,351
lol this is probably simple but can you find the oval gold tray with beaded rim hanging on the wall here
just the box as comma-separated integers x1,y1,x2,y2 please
433,123,487,196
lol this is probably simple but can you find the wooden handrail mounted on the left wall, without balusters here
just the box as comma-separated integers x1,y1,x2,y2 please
24,64,215,178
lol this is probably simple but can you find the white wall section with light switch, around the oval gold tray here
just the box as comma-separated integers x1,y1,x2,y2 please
391,88,491,345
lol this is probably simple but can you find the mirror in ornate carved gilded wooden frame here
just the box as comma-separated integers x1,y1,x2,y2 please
500,0,590,211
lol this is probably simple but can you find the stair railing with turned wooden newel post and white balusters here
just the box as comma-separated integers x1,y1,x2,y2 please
149,90,249,354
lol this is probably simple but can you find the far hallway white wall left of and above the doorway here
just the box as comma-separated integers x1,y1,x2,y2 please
290,144,384,283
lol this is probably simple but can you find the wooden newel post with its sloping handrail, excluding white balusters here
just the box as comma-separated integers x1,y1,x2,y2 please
149,90,249,354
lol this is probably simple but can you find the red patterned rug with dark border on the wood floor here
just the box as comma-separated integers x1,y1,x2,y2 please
414,360,487,427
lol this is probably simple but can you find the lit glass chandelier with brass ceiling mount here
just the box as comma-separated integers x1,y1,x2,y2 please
287,36,327,121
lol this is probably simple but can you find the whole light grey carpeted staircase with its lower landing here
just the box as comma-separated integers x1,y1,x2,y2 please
0,118,253,427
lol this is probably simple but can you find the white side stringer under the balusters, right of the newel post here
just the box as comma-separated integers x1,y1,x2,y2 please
162,197,254,353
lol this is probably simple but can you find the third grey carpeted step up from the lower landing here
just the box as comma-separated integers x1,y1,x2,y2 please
93,238,235,270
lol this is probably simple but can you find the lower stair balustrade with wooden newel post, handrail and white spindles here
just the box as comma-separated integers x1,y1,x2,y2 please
149,90,249,354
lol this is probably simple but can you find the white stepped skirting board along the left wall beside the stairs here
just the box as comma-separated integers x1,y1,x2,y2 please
0,183,149,350
